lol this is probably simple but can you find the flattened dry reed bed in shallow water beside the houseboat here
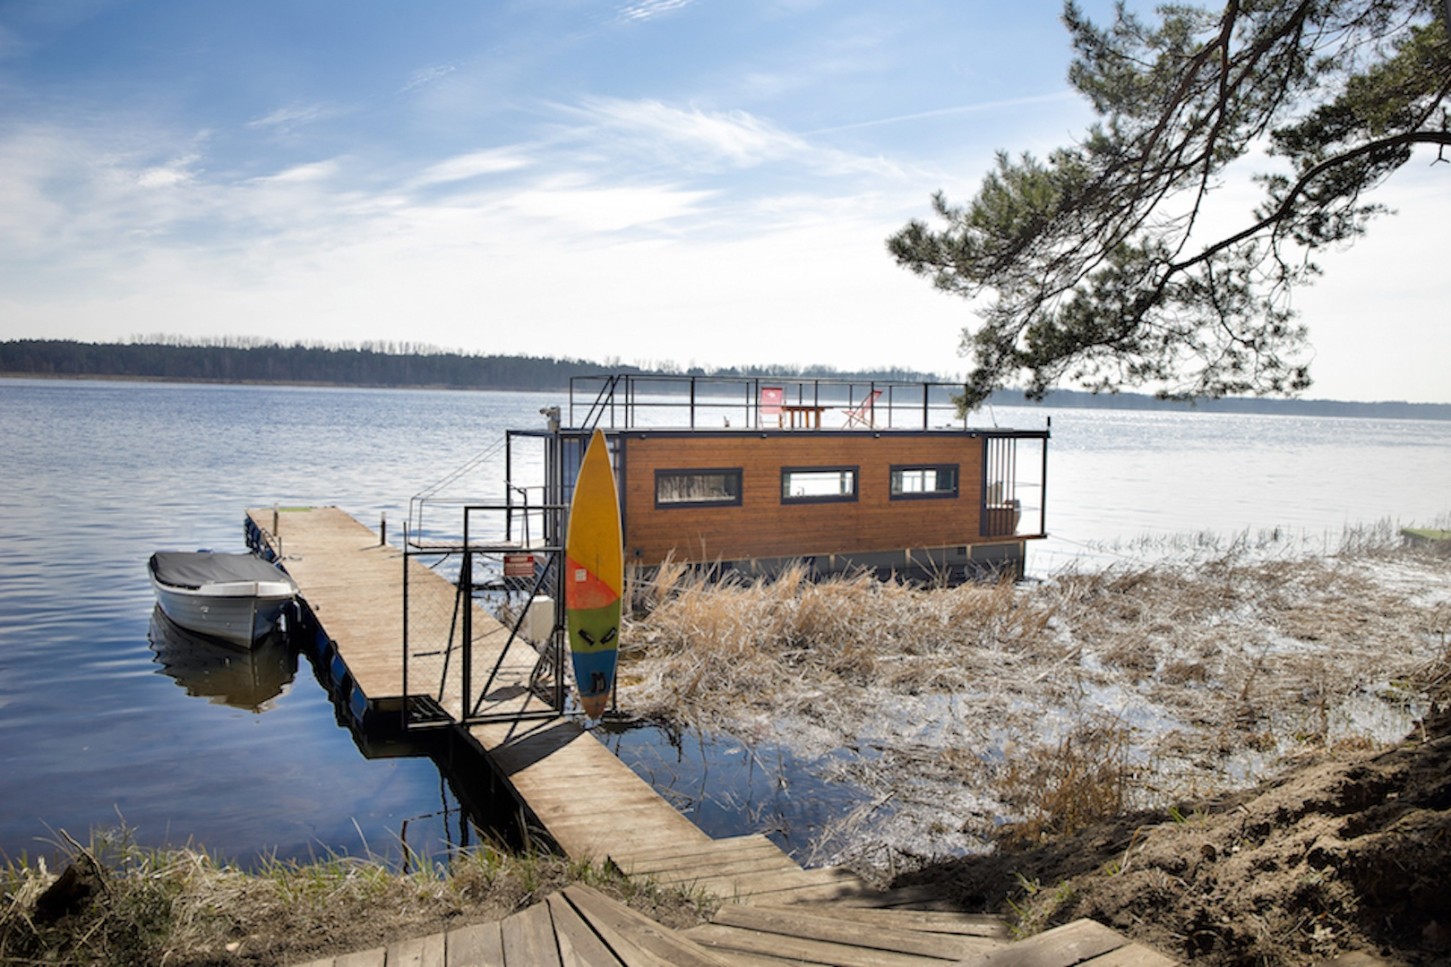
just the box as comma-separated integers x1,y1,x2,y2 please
621,529,1451,873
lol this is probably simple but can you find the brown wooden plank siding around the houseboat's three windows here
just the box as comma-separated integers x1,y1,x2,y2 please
621,431,984,565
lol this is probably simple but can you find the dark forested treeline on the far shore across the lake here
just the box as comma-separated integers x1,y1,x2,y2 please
0,335,1451,420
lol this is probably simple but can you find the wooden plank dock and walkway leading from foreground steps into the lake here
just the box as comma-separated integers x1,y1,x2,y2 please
248,507,1172,967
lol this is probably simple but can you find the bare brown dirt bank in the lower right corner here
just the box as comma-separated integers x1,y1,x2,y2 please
900,682,1451,964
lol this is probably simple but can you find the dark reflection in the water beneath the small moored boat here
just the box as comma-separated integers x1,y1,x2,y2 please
147,605,297,714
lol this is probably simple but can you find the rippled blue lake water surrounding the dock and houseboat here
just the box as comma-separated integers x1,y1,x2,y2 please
0,379,1451,861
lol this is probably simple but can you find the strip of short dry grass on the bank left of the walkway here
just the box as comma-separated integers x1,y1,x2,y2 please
0,831,704,964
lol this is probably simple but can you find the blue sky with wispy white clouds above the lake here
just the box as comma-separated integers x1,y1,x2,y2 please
0,0,1451,402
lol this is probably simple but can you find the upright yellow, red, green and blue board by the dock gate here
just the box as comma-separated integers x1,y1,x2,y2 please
564,430,625,719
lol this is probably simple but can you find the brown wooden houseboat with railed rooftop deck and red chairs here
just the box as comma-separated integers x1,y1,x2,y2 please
446,375,1049,581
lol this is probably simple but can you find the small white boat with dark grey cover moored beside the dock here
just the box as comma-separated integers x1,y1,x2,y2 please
147,550,297,648
